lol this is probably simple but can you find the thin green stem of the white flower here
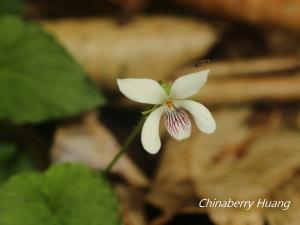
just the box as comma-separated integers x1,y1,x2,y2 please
105,115,147,173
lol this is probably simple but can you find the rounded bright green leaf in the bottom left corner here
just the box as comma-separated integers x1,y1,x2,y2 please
0,164,121,225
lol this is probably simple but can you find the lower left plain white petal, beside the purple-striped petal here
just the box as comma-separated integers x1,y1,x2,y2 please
142,106,165,154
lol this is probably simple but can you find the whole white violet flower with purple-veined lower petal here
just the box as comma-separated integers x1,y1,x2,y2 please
117,70,216,154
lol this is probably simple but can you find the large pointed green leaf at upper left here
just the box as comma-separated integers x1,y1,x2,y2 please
0,15,104,124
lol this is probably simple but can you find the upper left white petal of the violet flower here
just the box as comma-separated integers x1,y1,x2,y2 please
117,78,168,104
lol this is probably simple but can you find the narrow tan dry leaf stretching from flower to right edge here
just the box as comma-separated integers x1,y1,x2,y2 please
195,74,300,104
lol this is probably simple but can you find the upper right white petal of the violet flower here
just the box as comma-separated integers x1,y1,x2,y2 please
170,70,209,99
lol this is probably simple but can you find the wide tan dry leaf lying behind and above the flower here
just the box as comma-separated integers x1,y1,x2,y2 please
41,16,218,88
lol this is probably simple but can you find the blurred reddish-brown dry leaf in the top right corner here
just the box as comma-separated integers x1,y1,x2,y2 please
176,0,300,31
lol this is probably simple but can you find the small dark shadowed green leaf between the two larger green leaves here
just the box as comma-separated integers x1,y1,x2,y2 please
0,142,33,183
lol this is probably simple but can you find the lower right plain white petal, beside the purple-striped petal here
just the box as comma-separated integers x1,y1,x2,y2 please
176,100,216,134
